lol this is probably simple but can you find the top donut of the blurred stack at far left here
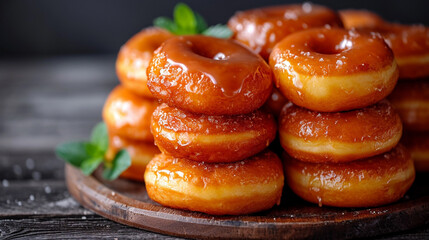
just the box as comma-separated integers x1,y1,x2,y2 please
116,27,173,97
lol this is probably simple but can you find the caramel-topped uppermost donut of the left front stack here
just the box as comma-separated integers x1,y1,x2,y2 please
148,35,272,115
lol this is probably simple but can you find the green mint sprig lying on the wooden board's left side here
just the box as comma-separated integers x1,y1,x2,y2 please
55,122,131,180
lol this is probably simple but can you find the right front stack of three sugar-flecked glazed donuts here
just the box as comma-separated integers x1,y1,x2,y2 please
269,25,415,207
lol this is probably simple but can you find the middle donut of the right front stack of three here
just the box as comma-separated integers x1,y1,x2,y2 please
279,100,402,163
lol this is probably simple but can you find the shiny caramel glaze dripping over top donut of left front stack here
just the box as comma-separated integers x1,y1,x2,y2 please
164,36,260,97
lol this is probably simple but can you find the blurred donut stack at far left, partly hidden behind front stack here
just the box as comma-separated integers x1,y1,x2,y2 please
103,28,172,181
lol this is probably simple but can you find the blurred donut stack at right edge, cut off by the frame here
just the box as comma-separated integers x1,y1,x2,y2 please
340,10,429,172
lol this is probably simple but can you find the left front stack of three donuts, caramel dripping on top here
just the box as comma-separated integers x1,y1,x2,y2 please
145,35,284,215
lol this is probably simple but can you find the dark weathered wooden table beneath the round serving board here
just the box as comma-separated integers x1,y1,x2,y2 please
0,56,429,239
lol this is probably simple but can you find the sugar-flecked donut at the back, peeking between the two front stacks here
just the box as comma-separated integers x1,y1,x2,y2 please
228,3,342,59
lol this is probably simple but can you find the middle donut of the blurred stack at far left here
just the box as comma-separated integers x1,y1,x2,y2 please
103,86,158,142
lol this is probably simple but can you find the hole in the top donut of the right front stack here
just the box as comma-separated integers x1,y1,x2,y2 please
310,35,353,55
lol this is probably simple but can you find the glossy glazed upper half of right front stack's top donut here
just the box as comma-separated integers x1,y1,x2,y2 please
271,29,394,76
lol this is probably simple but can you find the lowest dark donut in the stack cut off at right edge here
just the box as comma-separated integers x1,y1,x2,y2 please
401,131,429,172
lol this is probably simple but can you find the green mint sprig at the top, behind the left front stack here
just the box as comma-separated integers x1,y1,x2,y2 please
153,3,232,38
